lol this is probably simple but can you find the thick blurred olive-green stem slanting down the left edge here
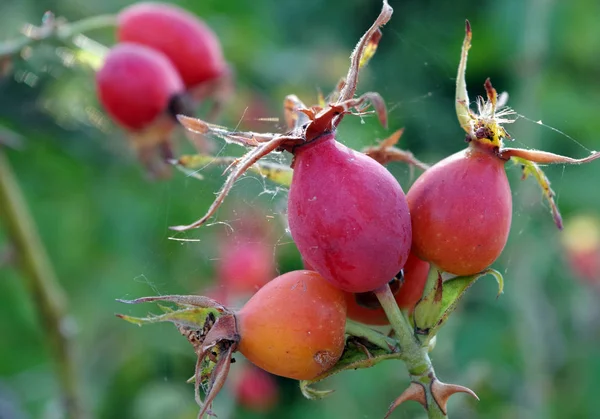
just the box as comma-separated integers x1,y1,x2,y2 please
0,148,85,419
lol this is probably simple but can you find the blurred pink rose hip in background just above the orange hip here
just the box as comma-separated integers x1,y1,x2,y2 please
216,237,275,294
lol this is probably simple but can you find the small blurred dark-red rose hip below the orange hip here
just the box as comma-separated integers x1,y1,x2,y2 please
234,365,279,413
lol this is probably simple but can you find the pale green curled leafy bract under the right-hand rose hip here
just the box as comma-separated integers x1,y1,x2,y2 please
426,269,504,342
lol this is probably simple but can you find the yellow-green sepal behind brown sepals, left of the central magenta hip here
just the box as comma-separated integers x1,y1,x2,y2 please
171,154,293,187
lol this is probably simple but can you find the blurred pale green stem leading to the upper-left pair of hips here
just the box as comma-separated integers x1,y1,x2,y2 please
0,15,117,58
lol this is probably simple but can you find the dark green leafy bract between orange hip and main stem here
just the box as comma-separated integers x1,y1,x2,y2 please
300,338,402,399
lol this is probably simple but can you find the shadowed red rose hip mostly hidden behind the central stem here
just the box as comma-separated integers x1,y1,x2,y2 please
345,252,429,326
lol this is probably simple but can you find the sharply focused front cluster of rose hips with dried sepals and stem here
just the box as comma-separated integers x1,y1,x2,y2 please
113,0,600,417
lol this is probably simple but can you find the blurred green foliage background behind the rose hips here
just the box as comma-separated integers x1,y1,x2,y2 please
0,0,600,419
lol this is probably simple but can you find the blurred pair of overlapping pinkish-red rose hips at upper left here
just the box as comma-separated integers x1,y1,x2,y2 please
96,3,229,175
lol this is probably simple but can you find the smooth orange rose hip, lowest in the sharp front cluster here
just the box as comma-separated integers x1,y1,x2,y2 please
236,271,346,380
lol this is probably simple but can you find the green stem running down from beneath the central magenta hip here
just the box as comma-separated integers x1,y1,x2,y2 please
375,284,448,419
